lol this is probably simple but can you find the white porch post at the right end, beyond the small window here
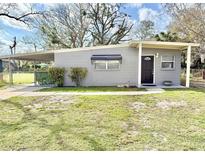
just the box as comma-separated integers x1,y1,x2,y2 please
186,45,191,88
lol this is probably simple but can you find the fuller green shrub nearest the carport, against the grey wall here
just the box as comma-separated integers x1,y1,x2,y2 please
48,67,65,87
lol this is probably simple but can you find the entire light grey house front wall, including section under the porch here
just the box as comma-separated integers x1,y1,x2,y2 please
54,47,181,86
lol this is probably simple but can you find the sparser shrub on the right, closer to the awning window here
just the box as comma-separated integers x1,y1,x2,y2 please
68,67,88,87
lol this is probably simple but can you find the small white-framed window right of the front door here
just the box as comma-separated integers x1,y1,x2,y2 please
161,56,175,70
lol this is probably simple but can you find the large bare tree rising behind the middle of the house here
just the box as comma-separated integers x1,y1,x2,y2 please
86,3,133,45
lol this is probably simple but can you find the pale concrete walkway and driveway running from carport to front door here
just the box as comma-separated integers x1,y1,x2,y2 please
0,85,164,100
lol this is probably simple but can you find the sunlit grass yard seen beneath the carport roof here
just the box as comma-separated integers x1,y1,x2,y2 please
3,73,34,84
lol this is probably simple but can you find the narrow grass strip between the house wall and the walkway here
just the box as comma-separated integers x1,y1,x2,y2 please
39,87,145,92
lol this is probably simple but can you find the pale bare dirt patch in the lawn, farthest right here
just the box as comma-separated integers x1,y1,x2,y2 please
156,101,187,110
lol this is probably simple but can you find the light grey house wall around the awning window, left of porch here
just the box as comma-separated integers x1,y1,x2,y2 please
54,47,137,86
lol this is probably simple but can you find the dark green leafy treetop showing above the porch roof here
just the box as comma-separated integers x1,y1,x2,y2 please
154,31,179,42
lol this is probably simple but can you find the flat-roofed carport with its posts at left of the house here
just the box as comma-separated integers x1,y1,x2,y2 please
0,51,54,85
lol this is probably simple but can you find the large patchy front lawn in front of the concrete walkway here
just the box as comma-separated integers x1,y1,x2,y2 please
0,89,205,150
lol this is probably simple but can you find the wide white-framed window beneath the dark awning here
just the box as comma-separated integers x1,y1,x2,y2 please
94,60,120,70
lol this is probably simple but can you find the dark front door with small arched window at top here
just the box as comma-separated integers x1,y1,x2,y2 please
141,56,154,84
